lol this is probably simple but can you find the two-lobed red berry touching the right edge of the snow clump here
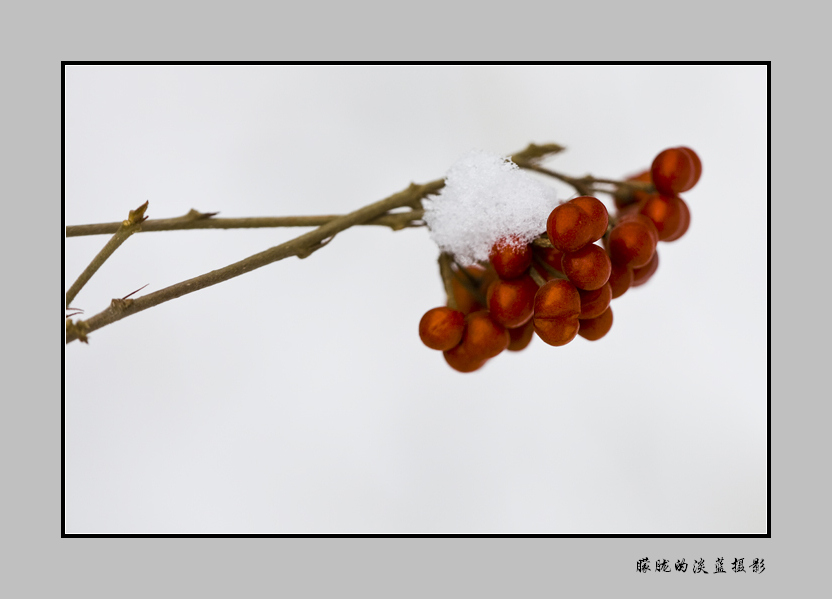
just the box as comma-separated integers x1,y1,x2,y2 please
546,196,609,252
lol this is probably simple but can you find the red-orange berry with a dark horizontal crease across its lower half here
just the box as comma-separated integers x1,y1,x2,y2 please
534,279,581,346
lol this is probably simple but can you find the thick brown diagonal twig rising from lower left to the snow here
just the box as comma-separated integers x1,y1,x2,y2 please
66,179,445,343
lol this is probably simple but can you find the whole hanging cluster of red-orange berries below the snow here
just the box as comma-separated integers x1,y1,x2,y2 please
419,147,702,372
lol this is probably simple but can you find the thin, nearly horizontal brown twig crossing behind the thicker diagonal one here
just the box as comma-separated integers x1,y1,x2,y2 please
66,209,425,237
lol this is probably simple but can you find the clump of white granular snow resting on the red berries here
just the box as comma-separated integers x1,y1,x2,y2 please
424,150,557,265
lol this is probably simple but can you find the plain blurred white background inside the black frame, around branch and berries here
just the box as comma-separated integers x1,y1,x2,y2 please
65,66,768,534
